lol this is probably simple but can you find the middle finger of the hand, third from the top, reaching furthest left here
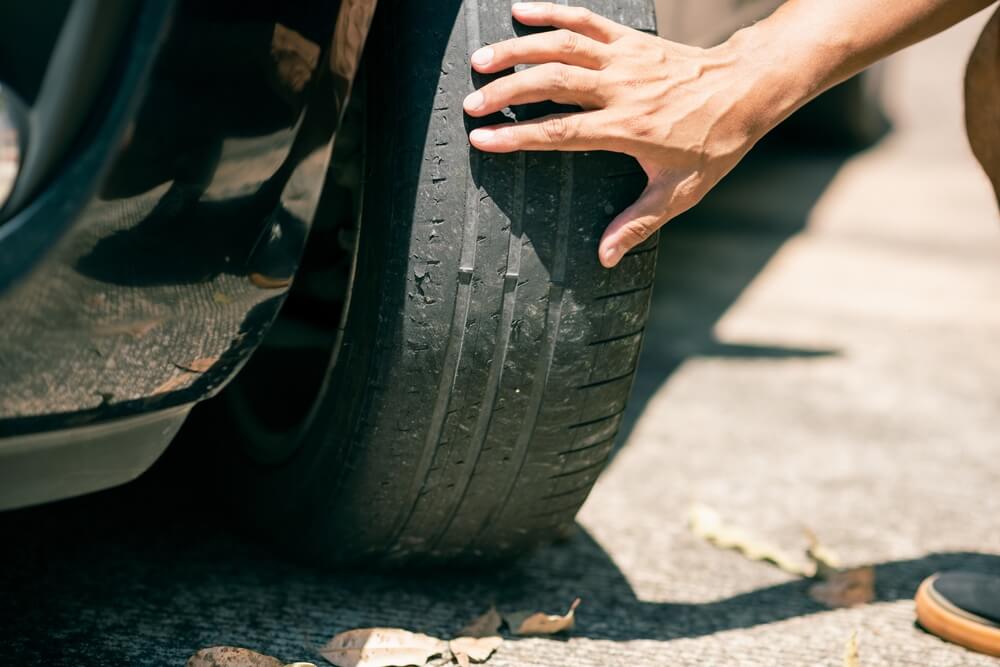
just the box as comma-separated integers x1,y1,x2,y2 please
462,63,602,116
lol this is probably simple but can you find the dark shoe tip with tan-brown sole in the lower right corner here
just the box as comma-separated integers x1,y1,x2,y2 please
916,572,1000,656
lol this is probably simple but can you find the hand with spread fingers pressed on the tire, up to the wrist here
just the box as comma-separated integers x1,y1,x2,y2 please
464,2,762,268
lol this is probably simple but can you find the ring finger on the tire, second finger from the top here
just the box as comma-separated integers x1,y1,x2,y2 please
470,30,609,74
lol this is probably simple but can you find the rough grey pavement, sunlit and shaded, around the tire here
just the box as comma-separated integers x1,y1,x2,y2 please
0,9,1000,666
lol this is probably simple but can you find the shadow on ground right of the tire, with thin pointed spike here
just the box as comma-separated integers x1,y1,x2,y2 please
616,135,853,452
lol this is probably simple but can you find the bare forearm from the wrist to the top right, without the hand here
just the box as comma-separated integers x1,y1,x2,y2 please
732,0,995,134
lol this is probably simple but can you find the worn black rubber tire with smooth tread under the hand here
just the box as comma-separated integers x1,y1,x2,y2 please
218,0,656,564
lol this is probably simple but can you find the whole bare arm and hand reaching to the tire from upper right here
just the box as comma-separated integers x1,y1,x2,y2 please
465,0,994,267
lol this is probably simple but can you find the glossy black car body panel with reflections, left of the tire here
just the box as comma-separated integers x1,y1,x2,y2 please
0,0,375,508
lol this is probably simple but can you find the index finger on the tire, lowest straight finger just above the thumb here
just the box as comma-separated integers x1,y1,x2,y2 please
469,111,601,153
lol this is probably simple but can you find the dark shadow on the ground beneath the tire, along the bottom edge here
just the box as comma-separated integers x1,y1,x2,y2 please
0,480,1000,665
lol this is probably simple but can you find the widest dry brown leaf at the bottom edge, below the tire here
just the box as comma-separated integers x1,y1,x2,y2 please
319,628,448,667
